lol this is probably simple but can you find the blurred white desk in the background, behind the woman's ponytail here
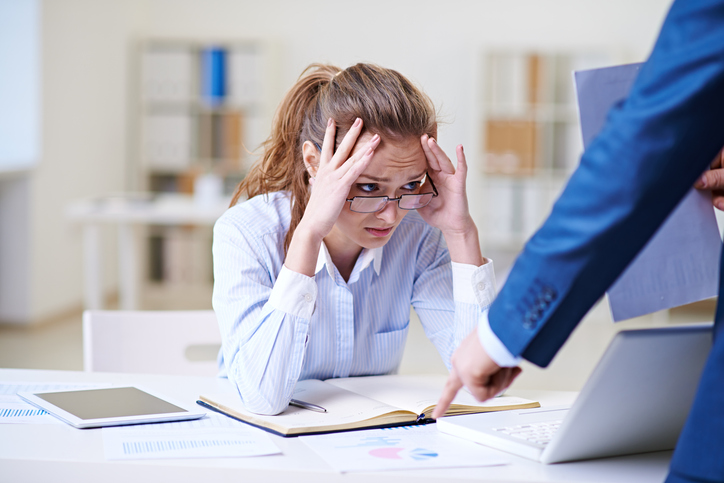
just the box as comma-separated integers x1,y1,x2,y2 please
66,193,229,310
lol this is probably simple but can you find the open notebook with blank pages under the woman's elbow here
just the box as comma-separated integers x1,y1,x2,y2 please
199,375,540,436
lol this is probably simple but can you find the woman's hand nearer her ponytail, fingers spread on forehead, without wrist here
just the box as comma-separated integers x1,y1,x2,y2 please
297,118,380,241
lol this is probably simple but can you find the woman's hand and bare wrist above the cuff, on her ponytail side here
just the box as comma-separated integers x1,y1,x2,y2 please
284,118,380,277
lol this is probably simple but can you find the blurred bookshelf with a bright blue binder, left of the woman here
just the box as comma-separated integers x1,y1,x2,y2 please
133,39,278,289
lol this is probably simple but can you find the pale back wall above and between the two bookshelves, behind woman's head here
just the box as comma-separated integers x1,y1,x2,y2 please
141,0,670,268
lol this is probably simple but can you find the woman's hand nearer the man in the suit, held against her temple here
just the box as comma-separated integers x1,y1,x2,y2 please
417,134,485,265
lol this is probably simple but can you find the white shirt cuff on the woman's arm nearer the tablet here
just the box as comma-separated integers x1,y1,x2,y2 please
268,265,317,319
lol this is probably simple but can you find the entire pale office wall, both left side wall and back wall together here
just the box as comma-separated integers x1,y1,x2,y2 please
5,0,670,322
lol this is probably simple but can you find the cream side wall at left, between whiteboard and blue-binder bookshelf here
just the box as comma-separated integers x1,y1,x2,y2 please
0,0,143,323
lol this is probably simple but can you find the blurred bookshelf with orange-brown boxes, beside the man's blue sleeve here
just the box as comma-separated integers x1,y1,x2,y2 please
480,50,623,258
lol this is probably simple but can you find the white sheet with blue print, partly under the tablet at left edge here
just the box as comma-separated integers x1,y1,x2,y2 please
0,382,109,424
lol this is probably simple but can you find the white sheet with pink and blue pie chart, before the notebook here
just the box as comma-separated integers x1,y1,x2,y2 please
299,424,510,473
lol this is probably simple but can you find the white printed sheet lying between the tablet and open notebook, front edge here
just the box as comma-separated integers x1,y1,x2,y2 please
103,413,281,460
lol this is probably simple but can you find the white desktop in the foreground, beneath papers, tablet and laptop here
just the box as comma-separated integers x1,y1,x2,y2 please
0,369,671,483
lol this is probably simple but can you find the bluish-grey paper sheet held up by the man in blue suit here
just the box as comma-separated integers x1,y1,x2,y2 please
575,64,721,322
